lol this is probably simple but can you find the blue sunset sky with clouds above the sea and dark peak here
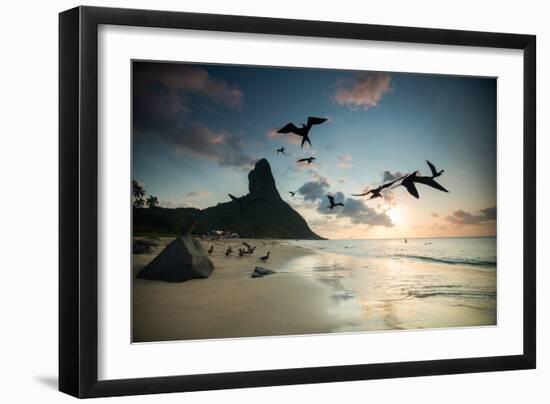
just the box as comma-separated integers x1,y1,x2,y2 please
132,61,496,239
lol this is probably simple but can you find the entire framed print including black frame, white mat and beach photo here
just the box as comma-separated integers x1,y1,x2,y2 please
59,7,536,397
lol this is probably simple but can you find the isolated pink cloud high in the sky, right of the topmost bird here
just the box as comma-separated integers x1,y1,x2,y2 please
334,72,391,110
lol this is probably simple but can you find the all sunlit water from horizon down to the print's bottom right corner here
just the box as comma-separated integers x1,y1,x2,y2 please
287,237,497,331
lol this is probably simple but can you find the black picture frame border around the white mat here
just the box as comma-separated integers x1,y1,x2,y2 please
59,7,536,398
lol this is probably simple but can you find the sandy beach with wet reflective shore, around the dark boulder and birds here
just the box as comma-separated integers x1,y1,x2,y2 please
133,239,496,342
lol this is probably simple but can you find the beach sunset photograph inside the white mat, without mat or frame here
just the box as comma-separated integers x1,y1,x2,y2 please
132,60,497,343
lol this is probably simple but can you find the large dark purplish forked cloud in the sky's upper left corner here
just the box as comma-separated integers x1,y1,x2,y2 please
132,62,256,168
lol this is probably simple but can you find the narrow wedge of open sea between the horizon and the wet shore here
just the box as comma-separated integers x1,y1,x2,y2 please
296,237,497,269
